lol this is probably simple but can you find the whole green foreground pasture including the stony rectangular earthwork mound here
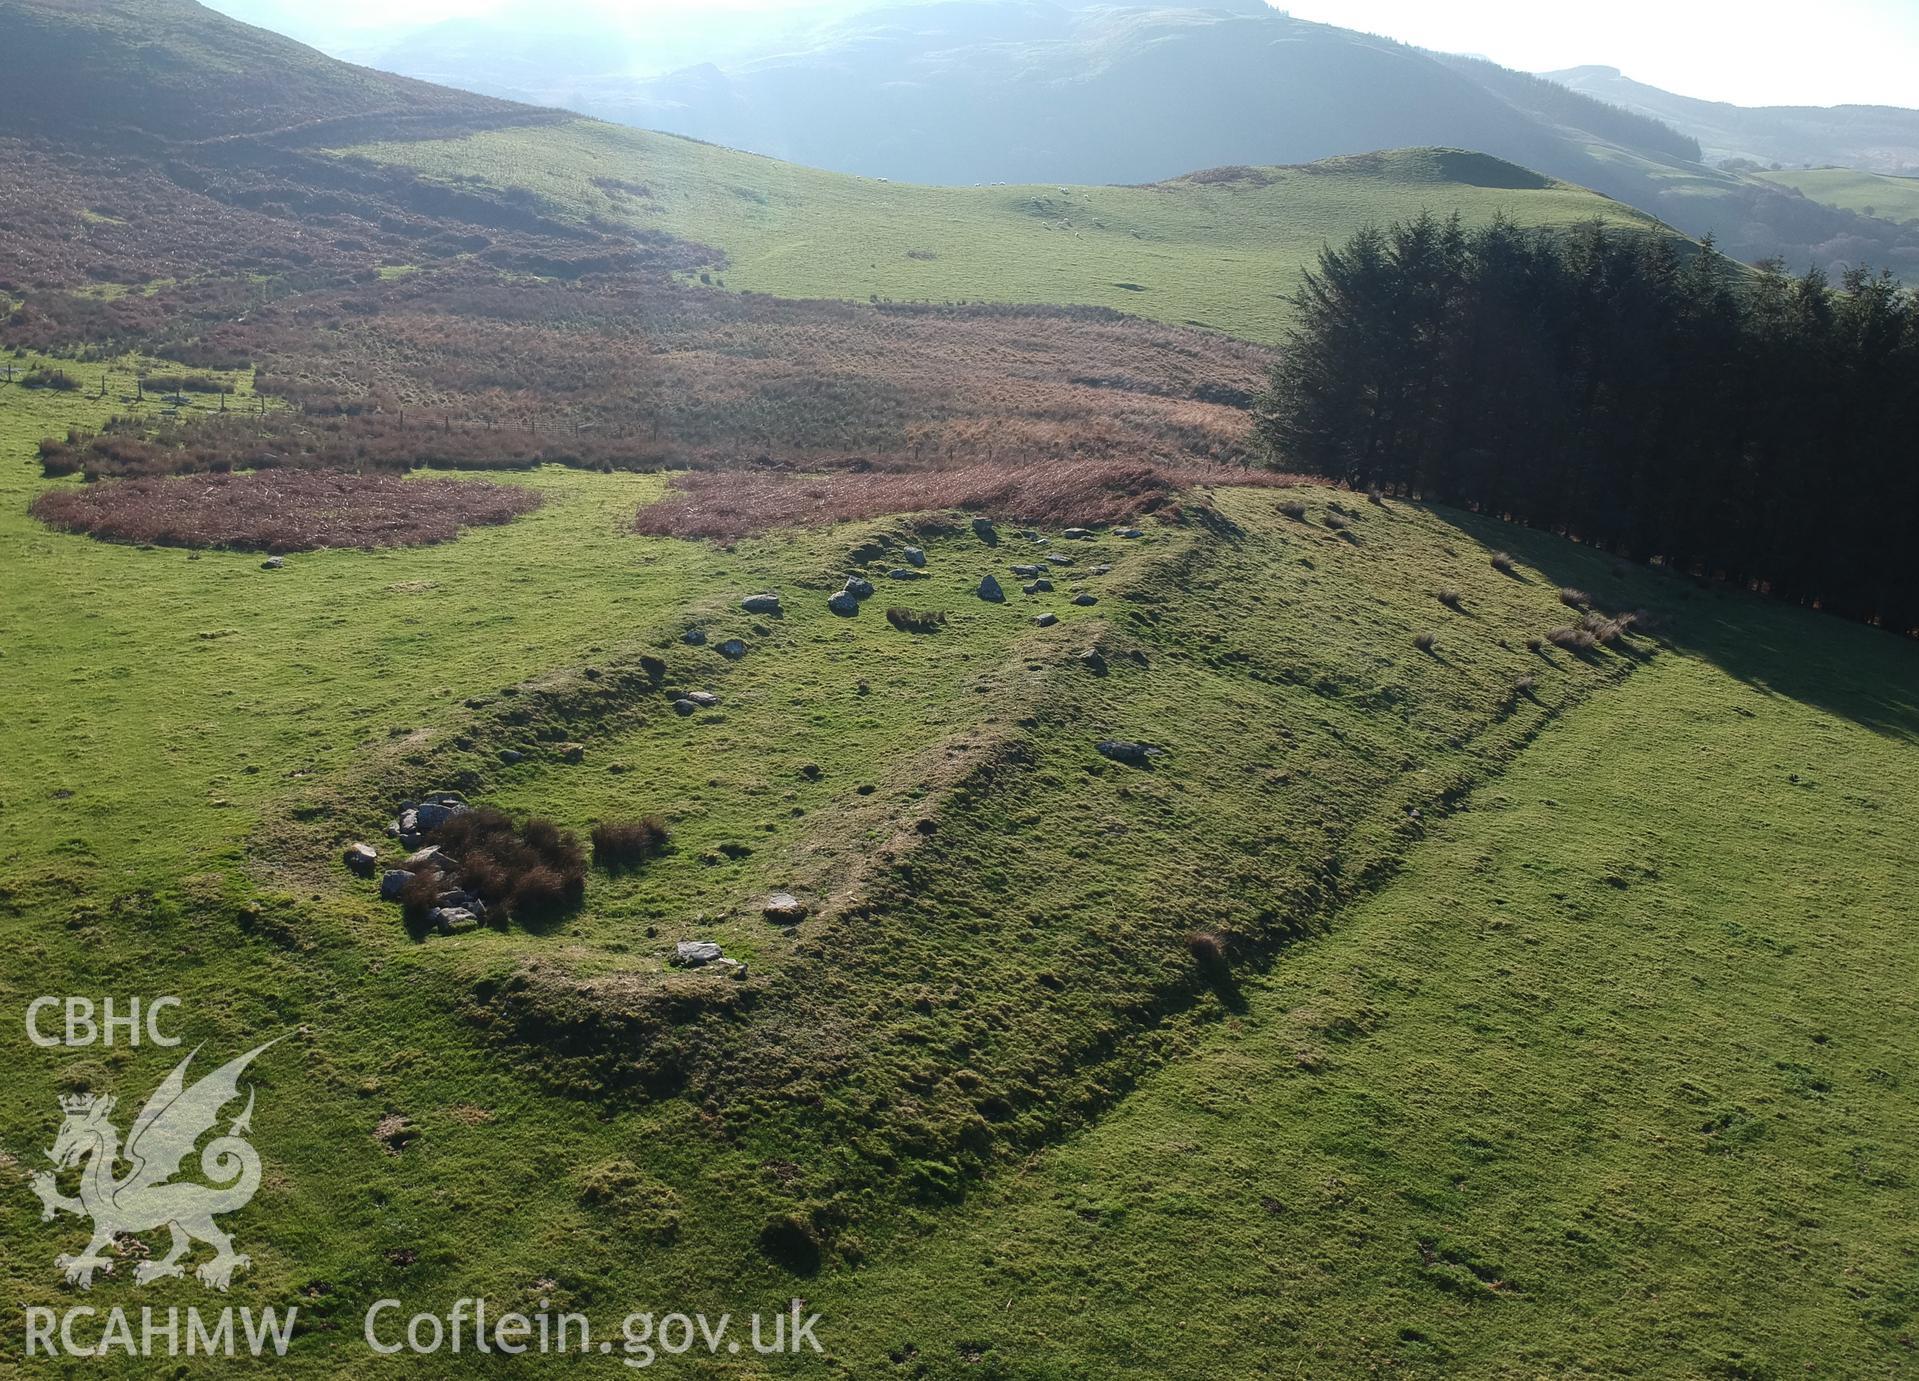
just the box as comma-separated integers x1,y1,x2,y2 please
0,364,1919,1377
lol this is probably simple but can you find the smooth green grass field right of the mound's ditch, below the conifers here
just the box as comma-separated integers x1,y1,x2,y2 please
814,567,1919,1377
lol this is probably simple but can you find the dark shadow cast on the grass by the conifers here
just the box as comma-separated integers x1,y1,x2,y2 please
1432,506,1919,742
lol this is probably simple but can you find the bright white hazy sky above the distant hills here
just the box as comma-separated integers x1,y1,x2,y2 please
211,0,1919,105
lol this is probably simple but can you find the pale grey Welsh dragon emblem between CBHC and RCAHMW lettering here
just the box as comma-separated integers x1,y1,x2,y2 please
33,1042,276,1291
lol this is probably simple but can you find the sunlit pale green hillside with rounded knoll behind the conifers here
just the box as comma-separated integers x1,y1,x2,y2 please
347,121,1656,343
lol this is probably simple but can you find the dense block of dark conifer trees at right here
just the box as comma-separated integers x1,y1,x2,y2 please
1259,217,1919,631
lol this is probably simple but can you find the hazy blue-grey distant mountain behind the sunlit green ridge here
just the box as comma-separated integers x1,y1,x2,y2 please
326,0,1919,274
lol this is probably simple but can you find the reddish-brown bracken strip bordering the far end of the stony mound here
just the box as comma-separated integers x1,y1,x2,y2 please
633,458,1299,541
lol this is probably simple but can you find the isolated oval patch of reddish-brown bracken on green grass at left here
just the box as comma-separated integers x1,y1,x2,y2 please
33,470,539,552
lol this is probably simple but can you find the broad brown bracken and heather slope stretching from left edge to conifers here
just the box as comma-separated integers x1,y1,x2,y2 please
11,122,1272,502
